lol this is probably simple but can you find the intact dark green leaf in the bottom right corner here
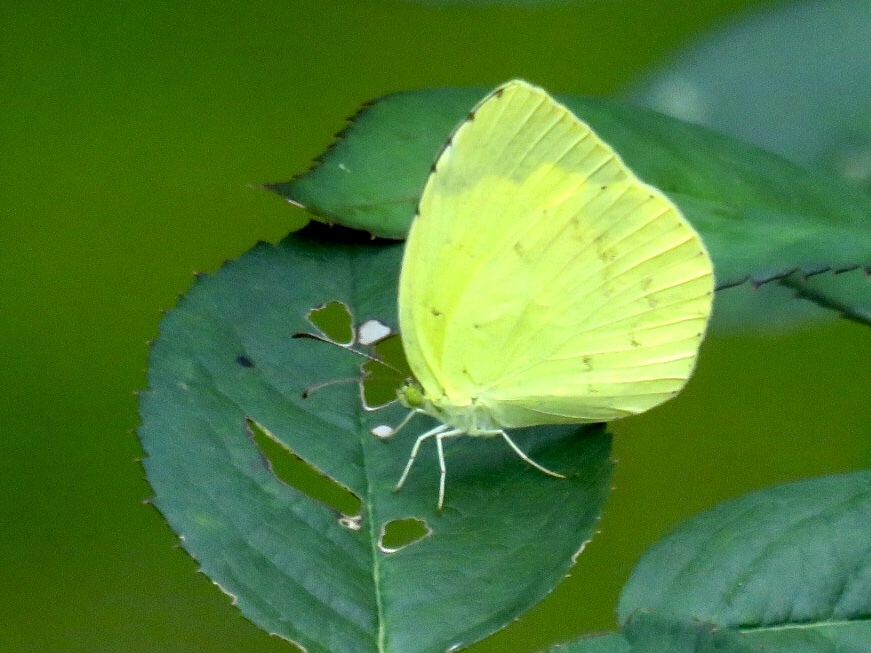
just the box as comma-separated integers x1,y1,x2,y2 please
618,472,871,651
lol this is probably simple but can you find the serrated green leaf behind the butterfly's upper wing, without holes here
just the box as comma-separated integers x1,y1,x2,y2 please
269,89,871,296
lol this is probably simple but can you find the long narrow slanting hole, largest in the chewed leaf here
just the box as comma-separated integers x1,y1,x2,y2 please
245,418,362,530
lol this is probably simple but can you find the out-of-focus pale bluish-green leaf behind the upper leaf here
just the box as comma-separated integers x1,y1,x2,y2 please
631,0,871,327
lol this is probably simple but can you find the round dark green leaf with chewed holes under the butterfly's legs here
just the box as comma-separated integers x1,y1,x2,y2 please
139,225,611,653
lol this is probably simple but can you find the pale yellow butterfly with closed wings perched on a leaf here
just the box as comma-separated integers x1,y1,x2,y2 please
384,80,714,510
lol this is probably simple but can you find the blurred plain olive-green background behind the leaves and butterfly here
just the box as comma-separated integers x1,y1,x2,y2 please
0,0,871,653
